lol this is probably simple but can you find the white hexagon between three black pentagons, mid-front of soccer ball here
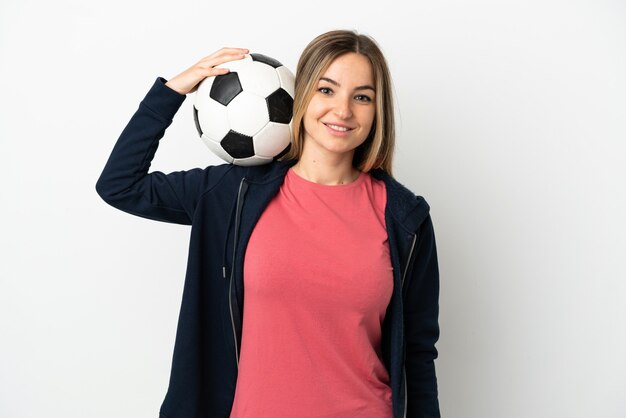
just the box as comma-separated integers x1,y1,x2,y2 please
227,91,270,136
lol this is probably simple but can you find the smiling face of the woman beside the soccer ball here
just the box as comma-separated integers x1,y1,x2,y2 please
303,52,376,161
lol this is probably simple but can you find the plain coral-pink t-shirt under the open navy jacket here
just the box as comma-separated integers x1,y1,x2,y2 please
230,169,393,418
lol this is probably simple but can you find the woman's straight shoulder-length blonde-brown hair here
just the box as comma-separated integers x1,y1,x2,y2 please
280,30,395,175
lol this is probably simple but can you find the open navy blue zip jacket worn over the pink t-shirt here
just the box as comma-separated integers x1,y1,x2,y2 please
96,77,440,418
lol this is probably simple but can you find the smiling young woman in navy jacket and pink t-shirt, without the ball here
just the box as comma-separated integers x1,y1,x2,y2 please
96,31,440,418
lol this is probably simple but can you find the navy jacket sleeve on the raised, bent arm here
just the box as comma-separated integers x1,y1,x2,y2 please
96,77,230,225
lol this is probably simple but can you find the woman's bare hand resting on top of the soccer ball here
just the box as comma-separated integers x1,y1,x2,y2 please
165,48,249,94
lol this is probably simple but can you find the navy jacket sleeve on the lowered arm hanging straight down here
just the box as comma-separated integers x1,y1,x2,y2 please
405,214,441,418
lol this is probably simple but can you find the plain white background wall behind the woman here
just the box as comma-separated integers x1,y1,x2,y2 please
0,0,626,418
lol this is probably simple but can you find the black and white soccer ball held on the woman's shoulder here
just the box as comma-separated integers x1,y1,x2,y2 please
193,54,294,166
